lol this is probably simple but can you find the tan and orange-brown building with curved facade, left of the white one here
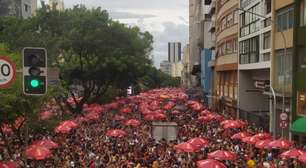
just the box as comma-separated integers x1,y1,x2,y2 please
213,0,239,118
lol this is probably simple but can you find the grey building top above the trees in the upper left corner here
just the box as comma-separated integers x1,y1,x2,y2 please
0,0,37,19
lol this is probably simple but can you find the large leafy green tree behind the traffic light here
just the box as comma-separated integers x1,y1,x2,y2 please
0,6,153,113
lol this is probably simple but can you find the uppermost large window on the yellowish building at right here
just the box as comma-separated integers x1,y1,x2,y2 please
276,6,294,31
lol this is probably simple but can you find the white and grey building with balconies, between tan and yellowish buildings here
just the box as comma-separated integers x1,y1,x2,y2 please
238,0,272,131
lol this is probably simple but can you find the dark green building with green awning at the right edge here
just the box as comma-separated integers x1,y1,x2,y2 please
289,0,306,145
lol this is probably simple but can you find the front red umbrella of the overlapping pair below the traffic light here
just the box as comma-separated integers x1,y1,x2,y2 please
26,145,51,160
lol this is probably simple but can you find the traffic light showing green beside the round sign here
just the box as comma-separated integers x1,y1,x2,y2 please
22,47,47,95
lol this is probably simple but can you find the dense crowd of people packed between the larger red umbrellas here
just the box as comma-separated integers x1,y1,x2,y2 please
0,89,305,168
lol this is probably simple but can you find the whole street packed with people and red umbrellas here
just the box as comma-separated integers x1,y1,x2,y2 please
0,88,306,168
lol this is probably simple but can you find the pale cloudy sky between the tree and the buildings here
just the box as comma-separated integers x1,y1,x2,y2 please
60,0,188,67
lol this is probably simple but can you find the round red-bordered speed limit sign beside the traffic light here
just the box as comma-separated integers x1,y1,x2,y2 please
0,56,16,88
